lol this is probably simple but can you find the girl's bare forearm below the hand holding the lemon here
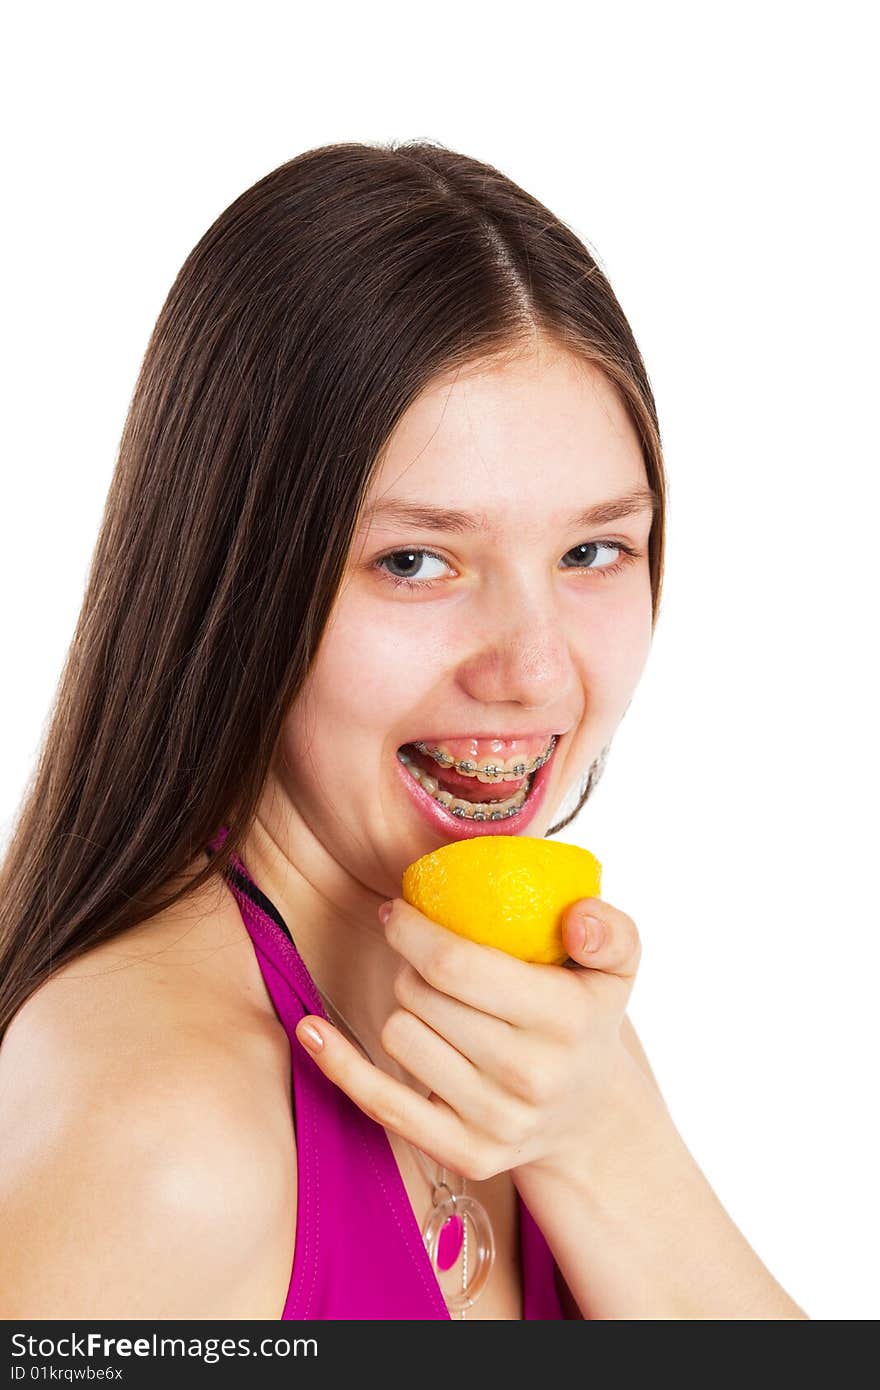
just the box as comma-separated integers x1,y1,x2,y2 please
514,1059,806,1321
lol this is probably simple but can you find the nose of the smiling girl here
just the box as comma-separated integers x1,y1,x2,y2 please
459,575,577,713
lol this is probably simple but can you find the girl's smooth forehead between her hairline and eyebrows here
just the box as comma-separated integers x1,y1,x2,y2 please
363,352,648,530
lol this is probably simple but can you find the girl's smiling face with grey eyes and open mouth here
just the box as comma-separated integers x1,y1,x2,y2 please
272,345,652,897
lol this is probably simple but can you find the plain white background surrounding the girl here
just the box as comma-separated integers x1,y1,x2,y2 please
0,0,880,1319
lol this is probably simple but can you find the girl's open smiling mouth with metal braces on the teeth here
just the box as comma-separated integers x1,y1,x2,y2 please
398,734,559,821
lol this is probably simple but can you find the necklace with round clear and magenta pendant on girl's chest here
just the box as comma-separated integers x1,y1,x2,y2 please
313,976,495,1318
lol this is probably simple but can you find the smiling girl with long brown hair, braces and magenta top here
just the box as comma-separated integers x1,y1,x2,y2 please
0,143,805,1319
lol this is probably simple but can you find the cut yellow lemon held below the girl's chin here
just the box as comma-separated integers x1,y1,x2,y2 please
402,835,602,965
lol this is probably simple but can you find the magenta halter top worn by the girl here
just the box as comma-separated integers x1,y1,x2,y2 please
209,827,564,1321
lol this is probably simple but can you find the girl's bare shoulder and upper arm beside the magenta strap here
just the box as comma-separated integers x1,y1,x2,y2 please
0,872,296,1319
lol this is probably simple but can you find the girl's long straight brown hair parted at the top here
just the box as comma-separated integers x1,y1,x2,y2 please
0,142,666,1038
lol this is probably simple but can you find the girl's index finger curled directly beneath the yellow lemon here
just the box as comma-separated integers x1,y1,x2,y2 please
385,898,559,1029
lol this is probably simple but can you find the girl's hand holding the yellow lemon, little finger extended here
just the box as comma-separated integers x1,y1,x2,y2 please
296,898,641,1182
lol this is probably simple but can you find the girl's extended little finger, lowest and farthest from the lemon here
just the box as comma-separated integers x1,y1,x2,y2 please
296,1013,474,1173
